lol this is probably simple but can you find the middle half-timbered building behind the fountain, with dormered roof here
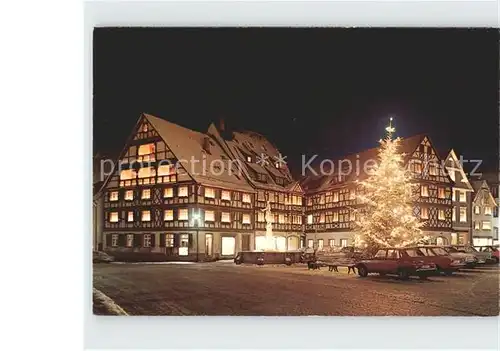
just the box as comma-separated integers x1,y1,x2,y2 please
208,123,304,250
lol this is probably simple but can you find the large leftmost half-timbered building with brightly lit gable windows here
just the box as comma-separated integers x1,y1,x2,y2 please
102,114,255,261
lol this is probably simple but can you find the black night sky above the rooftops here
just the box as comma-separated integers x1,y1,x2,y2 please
93,28,499,173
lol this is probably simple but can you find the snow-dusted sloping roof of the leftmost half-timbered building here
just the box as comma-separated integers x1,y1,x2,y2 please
143,113,253,192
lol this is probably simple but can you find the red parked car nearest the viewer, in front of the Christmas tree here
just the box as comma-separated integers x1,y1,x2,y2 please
356,248,436,279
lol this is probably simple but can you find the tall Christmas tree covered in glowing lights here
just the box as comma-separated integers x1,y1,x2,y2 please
355,118,423,249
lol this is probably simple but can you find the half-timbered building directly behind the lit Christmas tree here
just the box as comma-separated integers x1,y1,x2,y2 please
302,135,452,248
